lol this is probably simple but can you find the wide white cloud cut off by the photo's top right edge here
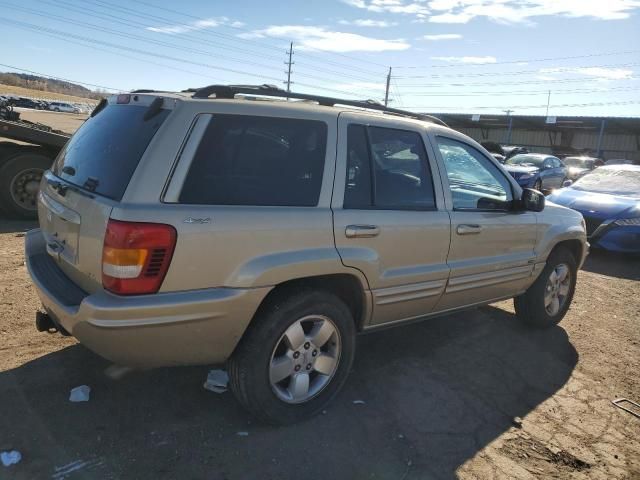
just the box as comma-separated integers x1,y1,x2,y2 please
343,0,640,24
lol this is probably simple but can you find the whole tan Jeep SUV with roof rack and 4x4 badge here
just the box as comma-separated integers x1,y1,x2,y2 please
25,86,587,423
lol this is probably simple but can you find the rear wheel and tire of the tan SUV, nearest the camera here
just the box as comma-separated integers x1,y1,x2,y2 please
228,290,356,424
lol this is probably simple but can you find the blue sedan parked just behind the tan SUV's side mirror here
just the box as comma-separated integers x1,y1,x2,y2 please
504,153,568,192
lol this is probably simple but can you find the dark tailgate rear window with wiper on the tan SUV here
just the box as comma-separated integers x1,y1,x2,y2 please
53,105,170,200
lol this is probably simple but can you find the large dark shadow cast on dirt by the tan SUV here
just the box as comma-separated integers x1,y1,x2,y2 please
0,307,578,479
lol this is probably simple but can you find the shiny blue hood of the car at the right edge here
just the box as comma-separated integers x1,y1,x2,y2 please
547,187,640,220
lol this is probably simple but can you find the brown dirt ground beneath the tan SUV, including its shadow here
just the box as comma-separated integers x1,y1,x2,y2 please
0,219,640,479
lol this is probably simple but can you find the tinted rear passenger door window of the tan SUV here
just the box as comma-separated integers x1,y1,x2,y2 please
344,125,435,209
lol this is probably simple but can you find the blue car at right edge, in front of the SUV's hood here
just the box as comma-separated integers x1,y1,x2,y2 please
547,165,640,253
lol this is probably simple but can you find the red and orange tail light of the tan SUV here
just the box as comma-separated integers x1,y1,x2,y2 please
102,219,177,295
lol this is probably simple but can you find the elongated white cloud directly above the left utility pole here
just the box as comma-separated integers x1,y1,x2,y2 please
238,25,411,52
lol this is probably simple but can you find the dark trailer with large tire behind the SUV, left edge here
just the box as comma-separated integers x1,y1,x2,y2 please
0,104,71,219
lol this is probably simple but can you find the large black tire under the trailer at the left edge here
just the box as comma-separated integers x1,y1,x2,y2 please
0,147,52,219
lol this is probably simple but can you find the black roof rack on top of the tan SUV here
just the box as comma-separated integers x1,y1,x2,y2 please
183,84,448,127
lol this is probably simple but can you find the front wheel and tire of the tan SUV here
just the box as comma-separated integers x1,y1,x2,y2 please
513,247,577,328
